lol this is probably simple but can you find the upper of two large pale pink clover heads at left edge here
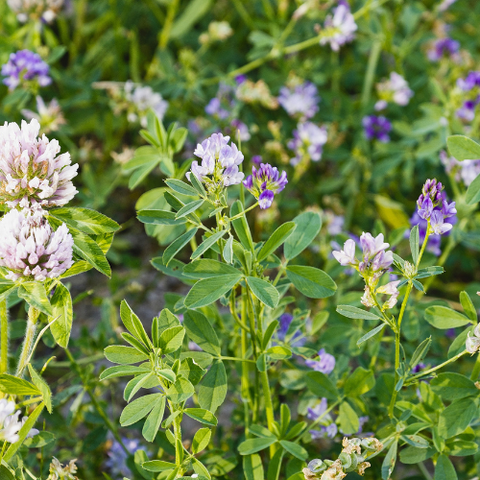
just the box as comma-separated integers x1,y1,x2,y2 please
0,119,78,208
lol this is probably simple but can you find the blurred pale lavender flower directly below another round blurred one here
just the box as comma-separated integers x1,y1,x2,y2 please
288,122,327,166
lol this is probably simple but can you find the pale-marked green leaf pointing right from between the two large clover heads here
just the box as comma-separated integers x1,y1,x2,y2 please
49,207,120,235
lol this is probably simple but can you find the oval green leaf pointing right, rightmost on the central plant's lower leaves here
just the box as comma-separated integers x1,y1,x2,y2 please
287,265,337,298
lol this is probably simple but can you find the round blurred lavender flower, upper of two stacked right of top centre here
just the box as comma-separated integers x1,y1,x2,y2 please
278,82,320,120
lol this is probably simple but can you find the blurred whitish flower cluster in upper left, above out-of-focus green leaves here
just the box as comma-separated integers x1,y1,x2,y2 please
124,80,168,128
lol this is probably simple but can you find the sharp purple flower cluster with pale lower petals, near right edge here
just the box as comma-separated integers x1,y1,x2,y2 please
417,179,457,235
